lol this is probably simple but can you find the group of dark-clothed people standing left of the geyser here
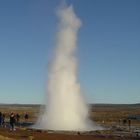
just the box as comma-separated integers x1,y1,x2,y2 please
0,112,29,131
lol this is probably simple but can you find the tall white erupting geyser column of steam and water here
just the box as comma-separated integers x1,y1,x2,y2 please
37,5,100,131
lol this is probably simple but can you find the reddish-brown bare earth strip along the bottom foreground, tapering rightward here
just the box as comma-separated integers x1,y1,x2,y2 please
0,128,138,140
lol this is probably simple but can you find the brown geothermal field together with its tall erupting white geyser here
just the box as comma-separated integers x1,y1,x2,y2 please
0,3,140,140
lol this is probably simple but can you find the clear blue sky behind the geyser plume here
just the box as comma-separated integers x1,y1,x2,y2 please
0,0,140,104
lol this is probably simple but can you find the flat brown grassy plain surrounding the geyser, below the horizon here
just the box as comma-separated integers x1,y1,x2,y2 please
0,104,140,140
